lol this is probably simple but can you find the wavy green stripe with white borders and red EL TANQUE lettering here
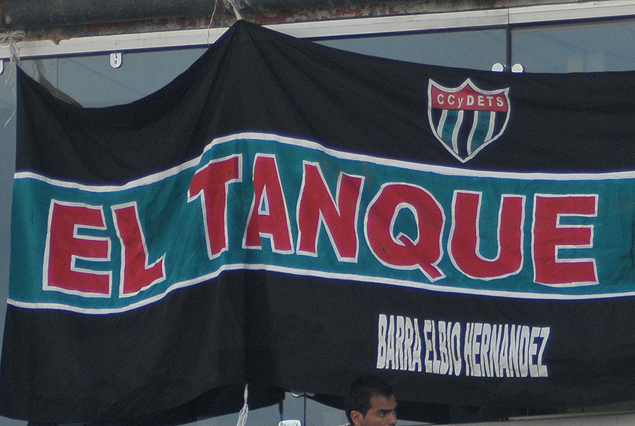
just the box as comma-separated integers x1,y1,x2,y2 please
10,134,635,313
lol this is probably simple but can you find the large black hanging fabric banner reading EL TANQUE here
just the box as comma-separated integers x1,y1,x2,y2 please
0,22,635,423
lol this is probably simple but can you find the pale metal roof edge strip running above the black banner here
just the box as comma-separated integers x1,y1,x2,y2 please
0,0,635,59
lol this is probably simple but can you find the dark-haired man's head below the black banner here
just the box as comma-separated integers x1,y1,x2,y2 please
346,376,397,426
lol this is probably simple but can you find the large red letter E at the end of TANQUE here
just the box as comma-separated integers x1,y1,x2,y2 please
533,194,598,286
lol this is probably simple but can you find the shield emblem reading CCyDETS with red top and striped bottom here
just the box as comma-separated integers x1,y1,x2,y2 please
428,78,510,163
